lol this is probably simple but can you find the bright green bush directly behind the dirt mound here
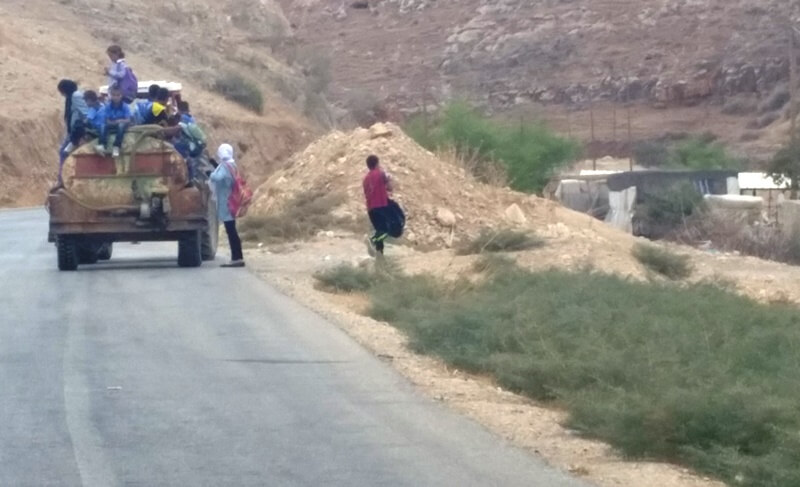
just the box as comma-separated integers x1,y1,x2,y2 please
405,102,580,192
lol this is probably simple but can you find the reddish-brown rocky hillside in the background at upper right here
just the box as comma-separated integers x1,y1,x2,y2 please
280,0,797,157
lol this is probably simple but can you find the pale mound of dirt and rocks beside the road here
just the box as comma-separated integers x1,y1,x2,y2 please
252,124,629,252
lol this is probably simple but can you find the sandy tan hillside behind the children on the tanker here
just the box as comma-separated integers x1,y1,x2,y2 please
0,0,319,206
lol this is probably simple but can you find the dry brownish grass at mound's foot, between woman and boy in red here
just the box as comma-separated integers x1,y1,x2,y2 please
241,190,354,242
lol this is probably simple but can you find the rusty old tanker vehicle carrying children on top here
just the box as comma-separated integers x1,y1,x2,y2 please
47,122,219,271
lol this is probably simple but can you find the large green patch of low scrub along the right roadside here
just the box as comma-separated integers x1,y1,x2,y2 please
369,266,800,487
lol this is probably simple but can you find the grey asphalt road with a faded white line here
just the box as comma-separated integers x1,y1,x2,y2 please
0,210,586,487
